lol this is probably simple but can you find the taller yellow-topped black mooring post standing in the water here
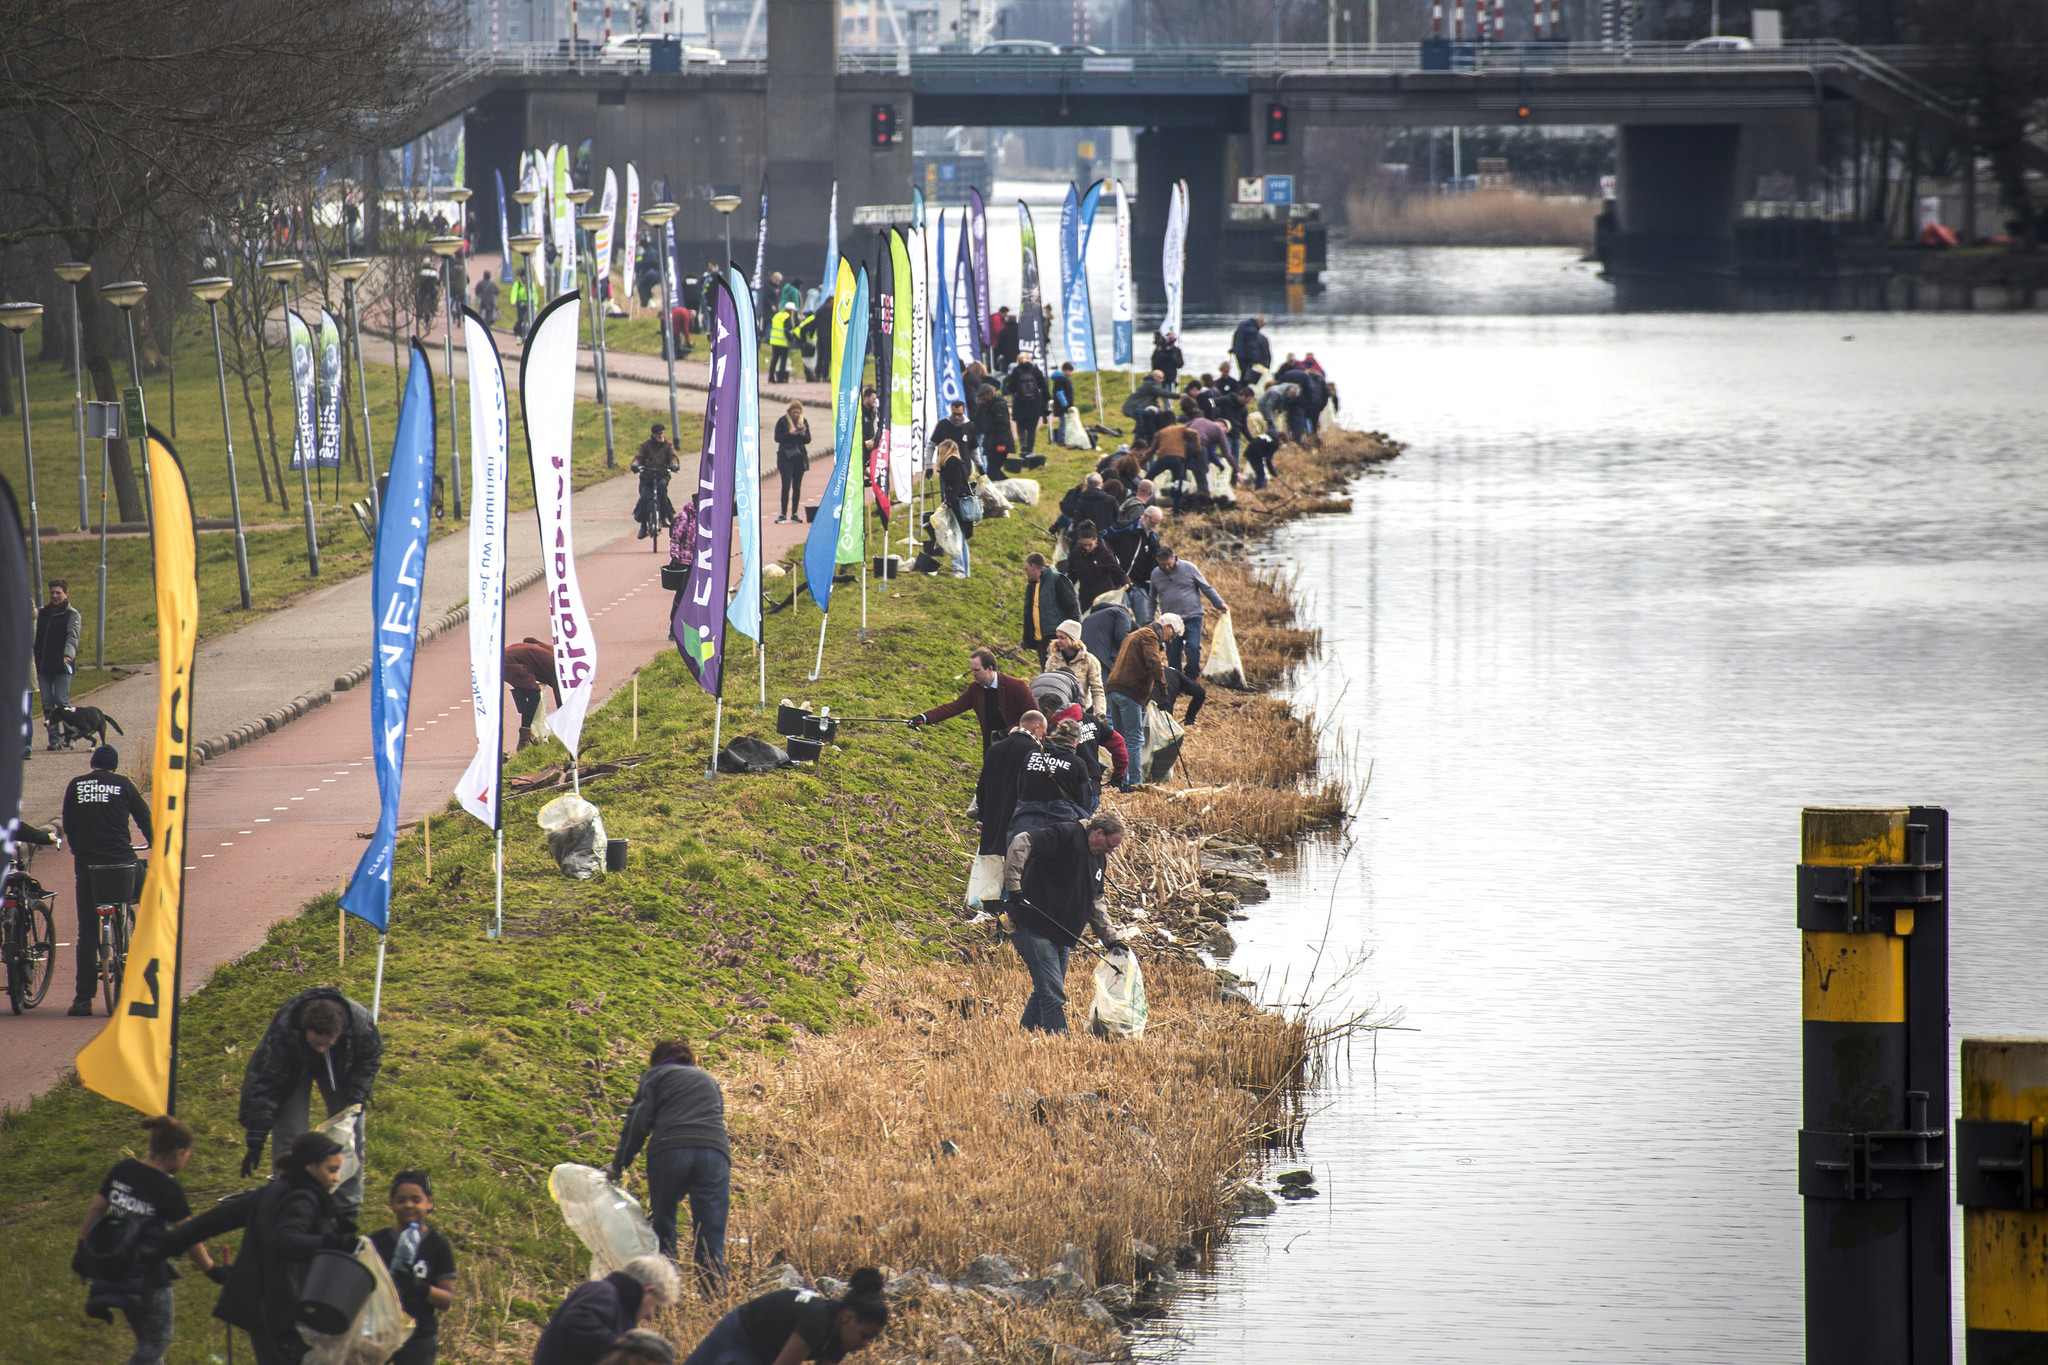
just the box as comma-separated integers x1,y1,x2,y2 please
1798,806,1952,1365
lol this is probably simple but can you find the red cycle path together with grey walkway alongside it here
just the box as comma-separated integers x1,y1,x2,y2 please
0,388,817,1109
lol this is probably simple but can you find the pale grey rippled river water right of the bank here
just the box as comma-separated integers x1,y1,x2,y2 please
1139,252,2048,1365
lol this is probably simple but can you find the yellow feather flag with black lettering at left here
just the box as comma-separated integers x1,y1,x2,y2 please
78,428,199,1115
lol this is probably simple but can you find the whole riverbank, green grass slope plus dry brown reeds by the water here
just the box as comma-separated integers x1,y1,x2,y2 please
0,381,1389,1365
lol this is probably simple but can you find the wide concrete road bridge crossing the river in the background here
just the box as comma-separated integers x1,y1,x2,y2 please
393,0,1966,307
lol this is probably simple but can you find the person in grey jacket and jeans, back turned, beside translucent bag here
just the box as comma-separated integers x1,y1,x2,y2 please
610,1038,733,1289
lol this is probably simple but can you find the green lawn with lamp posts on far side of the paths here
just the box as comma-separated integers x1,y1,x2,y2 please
0,315,702,694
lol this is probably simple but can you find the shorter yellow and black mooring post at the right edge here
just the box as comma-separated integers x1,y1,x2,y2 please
1956,1038,2048,1365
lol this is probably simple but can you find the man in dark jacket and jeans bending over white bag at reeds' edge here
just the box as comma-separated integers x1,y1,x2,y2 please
1004,810,1124,1033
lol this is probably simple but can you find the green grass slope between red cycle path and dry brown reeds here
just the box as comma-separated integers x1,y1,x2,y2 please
0,377,1146,1365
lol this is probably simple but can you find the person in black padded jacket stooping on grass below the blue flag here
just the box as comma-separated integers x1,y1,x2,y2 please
242,986,383,1228
